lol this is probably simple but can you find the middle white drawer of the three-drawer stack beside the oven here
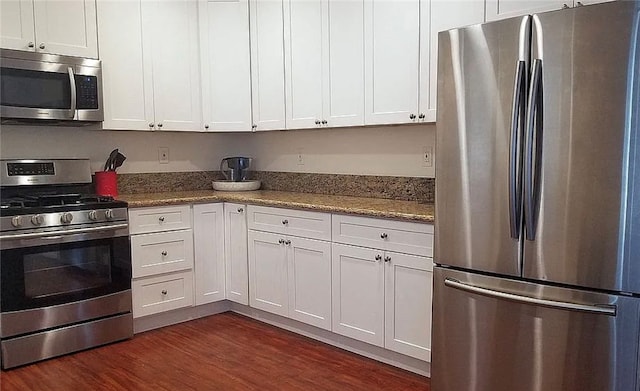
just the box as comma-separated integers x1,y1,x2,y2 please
131,229,193,278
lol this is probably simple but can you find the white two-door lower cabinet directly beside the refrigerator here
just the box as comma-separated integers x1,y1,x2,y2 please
332,243,433,361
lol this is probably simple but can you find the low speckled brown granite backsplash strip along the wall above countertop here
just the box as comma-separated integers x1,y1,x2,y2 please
118,171,435,203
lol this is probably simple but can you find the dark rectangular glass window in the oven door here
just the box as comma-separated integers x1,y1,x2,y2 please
24,245,112,299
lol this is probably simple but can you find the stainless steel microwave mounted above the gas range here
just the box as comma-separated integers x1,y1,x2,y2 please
0,49,104,125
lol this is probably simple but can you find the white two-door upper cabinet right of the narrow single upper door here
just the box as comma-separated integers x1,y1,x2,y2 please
284,0,364,129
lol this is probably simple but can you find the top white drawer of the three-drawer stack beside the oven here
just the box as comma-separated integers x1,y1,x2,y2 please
129,205,191,234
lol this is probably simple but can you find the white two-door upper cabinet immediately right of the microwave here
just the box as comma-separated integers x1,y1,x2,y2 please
98,0,202,130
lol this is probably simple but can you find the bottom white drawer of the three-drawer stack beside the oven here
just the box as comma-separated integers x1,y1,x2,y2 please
132,270,193,318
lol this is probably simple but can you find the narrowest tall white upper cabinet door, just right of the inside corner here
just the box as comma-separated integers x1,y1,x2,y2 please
249,0,285,130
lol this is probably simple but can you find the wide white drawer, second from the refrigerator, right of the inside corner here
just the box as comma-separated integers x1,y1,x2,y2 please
247,205,331,240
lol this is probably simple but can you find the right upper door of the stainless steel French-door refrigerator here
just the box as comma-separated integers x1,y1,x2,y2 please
524,1,640,292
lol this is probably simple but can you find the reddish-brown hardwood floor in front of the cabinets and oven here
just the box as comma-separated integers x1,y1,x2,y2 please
0,313,430,391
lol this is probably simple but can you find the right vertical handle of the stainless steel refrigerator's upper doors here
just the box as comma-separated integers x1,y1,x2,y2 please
524,58,542,240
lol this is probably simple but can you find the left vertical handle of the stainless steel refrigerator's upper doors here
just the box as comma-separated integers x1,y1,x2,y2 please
509,60,527,239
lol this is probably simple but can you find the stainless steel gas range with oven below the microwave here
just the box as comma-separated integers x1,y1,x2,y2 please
0,160,133,369
